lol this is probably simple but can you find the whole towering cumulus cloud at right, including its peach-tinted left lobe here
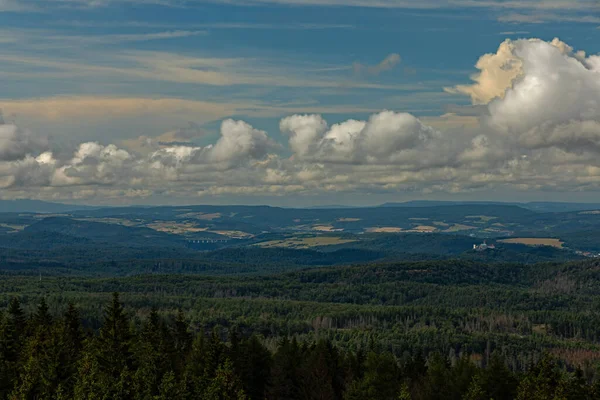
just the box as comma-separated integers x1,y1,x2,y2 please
448,39,600,155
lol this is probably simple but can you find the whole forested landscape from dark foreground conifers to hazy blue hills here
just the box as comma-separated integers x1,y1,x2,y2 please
0,205,600,400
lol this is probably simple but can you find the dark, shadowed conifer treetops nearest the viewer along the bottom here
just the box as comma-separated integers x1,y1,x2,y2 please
0,293,600,400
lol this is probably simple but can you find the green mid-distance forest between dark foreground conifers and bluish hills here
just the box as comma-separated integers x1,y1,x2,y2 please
0,260,600,376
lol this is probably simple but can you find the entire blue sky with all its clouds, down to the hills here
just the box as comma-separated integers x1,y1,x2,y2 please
0,0,600,206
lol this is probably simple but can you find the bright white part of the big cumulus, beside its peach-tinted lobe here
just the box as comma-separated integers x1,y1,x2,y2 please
488,39,600,139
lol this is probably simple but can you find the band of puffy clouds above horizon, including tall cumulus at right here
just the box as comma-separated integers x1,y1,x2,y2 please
0,39,600,203
